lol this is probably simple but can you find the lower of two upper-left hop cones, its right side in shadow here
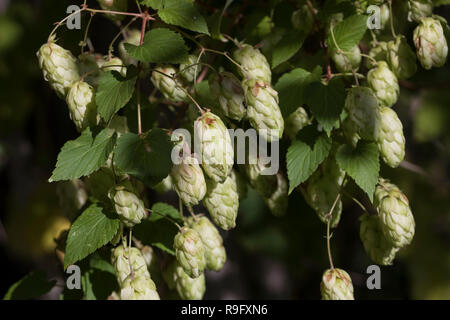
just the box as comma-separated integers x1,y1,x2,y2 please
66,81,97,132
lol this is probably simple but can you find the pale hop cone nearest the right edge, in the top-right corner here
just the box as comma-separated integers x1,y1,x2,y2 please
413,18,448,70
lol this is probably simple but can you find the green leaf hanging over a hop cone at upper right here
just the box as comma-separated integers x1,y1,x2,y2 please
328,14,368,51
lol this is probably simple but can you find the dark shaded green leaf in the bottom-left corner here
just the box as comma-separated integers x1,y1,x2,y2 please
3,271,56,300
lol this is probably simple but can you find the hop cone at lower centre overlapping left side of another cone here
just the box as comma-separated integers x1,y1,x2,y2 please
173,227,206,278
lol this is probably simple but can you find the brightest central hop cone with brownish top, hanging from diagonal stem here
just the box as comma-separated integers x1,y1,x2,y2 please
194,112,234,182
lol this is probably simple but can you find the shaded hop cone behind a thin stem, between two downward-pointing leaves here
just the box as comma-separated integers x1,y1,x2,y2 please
303,158,345,228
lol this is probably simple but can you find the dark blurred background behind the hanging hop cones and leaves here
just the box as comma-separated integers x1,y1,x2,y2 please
0,0,450,299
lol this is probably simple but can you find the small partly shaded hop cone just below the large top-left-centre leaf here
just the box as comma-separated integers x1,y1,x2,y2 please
151,66,188,102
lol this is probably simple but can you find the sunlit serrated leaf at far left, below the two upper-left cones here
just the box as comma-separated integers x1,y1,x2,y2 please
48,128,116,182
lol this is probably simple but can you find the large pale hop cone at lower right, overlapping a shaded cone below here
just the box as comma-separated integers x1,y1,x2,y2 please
374,179,416,248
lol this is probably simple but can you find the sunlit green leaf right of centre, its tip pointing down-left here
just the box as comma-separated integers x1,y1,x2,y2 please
286,125,331,193
